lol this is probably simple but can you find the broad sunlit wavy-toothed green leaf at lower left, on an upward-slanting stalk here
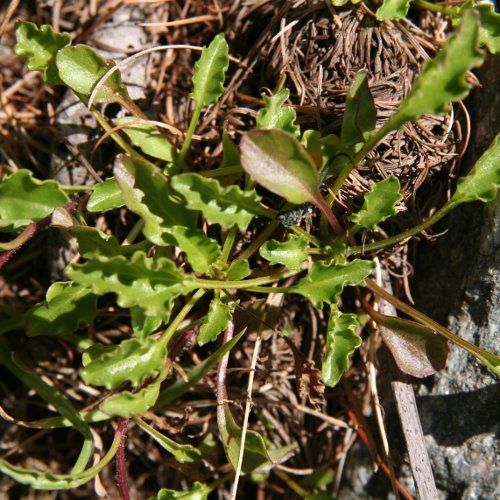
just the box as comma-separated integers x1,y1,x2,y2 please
80,337,167,390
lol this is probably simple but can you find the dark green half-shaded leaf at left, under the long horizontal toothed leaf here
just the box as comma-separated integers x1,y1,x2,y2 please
26,282,97,336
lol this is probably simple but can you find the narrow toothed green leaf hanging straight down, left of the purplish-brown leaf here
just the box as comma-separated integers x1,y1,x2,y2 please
321,304,361,387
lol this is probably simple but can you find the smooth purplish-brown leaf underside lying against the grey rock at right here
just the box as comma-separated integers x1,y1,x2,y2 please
375,314,448,378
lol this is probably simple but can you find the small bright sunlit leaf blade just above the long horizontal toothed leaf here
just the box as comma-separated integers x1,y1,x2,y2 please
170,226,221,273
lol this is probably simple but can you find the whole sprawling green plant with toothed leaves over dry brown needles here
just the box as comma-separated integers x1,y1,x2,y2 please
0,5,500,498
